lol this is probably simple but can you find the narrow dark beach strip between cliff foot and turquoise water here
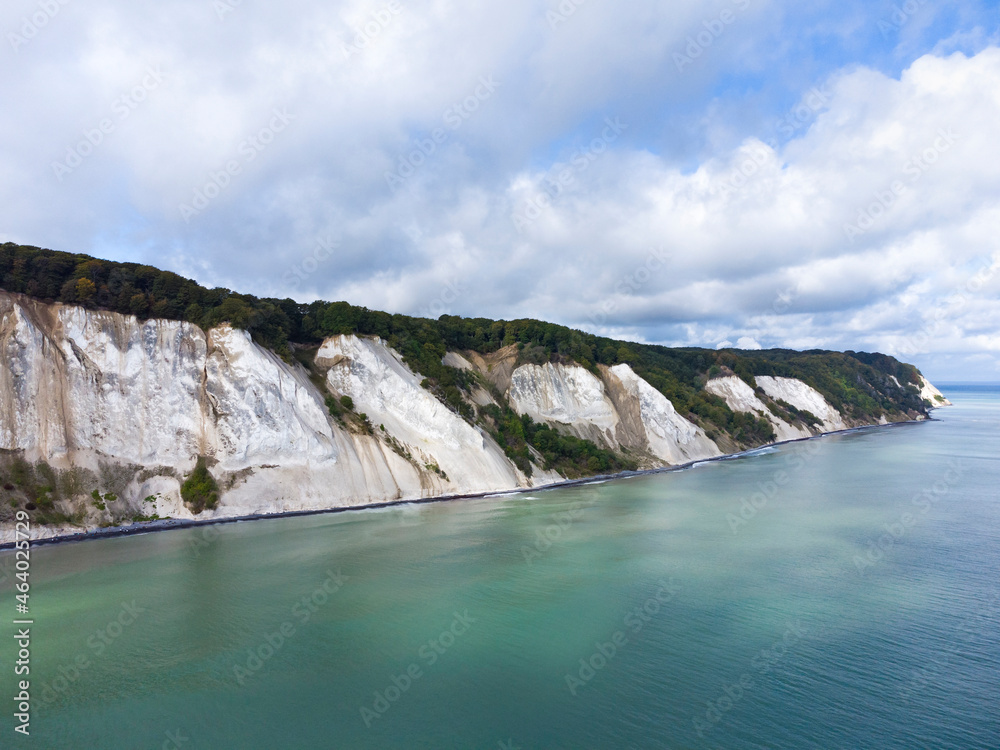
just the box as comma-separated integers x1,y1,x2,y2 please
0,418,936,552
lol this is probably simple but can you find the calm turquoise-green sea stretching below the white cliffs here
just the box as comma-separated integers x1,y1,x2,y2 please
0,386,1000,750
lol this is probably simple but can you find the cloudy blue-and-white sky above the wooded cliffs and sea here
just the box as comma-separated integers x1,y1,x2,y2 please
0,0,1000,380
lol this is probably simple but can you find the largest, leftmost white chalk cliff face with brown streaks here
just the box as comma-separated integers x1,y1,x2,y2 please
0,294,423,523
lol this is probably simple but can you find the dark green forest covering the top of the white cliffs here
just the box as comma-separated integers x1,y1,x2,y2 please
0,243,927,465
